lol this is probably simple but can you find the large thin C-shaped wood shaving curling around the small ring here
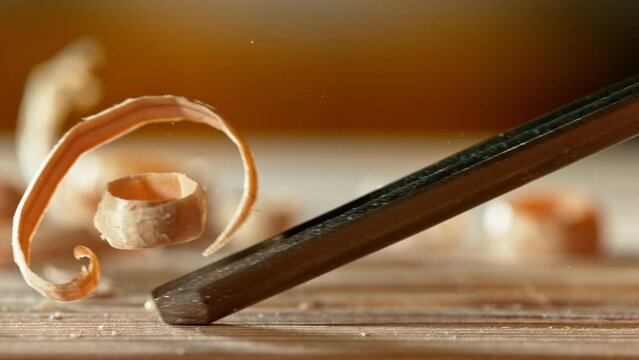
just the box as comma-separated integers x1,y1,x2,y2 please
12,96,257,301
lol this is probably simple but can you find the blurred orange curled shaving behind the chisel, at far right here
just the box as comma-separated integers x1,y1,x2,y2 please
482,187,602,261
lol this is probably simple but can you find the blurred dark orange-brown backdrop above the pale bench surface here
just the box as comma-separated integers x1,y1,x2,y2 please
0,0,639,133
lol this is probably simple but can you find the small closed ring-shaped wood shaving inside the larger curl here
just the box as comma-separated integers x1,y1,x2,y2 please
94,173,207,250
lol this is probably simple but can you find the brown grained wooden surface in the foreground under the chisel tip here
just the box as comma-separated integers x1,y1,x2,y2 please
0,252,639,359
